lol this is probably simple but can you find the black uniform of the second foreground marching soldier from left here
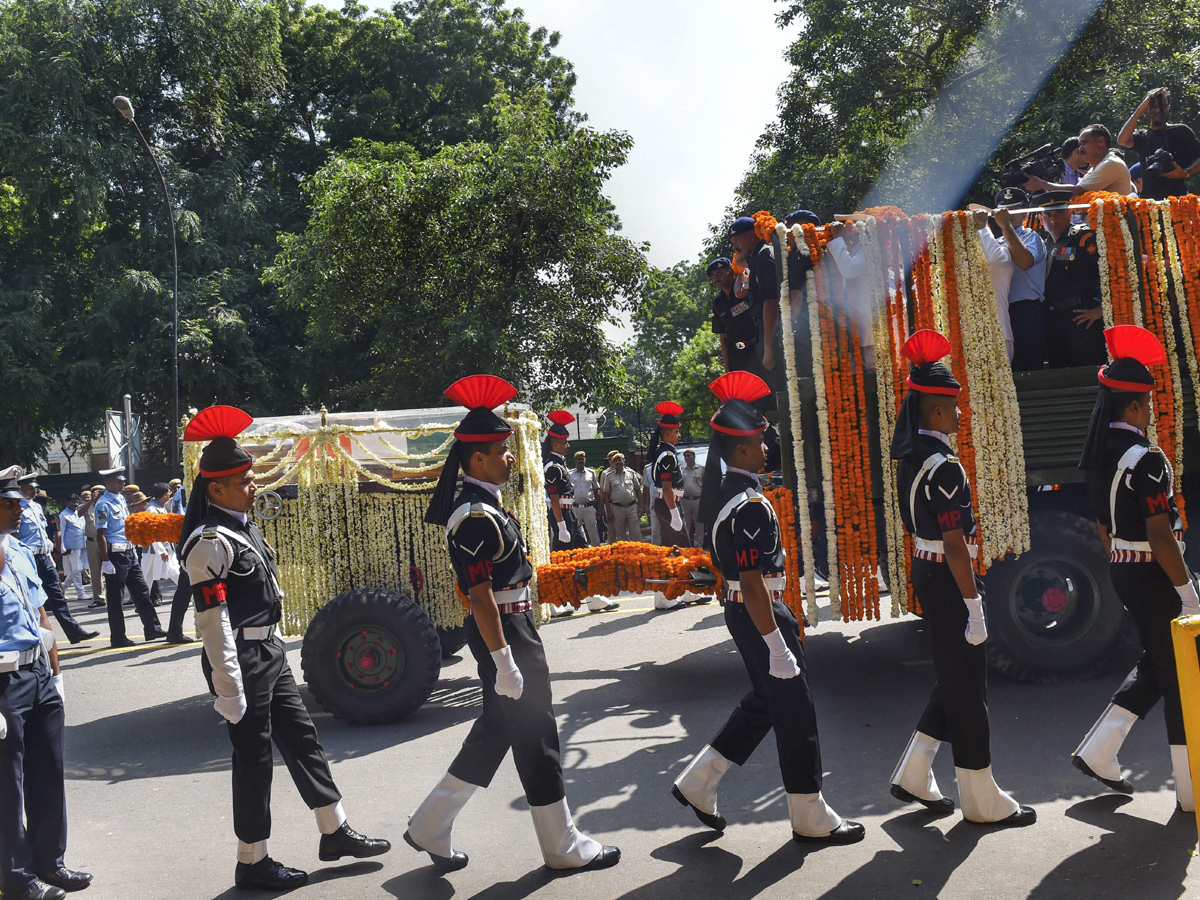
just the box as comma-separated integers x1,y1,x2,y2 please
446,482,566,806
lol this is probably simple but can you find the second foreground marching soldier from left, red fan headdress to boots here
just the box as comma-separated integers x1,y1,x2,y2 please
404,374,620,872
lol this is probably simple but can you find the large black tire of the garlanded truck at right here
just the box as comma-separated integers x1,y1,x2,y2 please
985,511,1136,684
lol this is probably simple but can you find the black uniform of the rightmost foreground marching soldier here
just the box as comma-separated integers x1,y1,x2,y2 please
1087,427,1187,745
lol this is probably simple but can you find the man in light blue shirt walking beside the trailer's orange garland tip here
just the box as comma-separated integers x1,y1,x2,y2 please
95,466,167,647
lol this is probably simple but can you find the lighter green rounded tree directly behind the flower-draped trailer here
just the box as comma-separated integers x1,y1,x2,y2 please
269,97,644,408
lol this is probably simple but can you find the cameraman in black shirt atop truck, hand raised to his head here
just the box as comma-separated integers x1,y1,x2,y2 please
1117,88,1200,200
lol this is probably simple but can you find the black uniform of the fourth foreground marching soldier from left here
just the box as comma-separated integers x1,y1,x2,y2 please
896,433,991,769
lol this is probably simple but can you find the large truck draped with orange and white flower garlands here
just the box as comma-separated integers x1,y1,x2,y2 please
756,194,1200,683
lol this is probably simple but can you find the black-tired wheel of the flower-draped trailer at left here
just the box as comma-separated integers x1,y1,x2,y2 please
300,588,442,725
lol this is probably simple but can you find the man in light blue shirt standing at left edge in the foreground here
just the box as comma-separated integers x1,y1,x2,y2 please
0,467,91,900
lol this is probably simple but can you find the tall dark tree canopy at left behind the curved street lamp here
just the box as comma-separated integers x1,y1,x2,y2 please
0,0,582,463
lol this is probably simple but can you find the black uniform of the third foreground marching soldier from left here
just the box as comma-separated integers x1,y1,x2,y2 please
712,472,821,793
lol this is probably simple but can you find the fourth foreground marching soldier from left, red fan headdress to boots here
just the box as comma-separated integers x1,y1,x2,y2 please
892,329,1037,827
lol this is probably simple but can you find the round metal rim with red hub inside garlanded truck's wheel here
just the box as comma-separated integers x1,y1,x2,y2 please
1008,559,1100,648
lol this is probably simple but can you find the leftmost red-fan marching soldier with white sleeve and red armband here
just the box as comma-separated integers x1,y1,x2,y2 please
177,407,391,890
